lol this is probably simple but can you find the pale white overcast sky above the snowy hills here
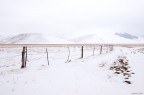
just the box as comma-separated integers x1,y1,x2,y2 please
0,0,144,35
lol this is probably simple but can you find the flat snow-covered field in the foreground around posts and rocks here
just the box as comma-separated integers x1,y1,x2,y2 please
0,47,144,95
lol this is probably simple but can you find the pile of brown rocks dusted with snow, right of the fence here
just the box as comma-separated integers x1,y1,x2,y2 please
110,56,134,84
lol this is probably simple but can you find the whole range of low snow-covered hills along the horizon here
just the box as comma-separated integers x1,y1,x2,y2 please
0,32,144,44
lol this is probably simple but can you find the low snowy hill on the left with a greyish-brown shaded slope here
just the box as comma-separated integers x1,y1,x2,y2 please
0,33,72,44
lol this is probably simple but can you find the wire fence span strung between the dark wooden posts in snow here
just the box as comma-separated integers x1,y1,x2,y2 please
0,46,113,67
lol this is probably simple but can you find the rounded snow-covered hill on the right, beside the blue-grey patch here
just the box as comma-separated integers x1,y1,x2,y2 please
73,33,143,44
